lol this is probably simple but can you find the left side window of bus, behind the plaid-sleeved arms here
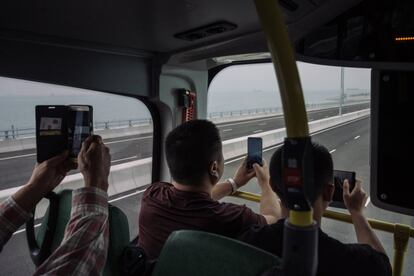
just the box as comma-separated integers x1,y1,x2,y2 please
0,77,153,275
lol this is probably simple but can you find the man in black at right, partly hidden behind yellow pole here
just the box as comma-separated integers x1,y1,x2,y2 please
239,143,391,275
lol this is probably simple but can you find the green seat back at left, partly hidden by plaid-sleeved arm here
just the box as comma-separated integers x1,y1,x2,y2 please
26,190,130,275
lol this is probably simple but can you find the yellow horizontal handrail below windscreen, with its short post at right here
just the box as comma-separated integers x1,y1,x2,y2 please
233,191,414,276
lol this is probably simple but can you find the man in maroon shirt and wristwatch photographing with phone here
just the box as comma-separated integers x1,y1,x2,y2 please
138,120,281,260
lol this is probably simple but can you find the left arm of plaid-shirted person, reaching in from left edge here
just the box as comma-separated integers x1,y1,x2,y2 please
0,152,74,251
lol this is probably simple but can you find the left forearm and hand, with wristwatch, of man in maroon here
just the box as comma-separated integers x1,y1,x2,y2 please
211,158,255,200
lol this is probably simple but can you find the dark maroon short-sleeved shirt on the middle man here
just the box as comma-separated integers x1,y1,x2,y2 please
138,182,266,260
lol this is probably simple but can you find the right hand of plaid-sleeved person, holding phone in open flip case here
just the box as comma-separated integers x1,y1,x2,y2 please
78,135,111,191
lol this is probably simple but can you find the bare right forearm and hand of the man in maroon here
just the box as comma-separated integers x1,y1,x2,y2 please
253,160,283,224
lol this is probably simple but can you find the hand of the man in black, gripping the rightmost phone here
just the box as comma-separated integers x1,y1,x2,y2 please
343,179,368,215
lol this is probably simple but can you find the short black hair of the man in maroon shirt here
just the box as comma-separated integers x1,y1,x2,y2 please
165,120,222,185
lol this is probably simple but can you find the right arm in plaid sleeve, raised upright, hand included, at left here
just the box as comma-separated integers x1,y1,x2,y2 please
35,136,110,275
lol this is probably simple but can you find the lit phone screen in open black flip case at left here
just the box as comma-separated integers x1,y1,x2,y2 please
68,105,93,158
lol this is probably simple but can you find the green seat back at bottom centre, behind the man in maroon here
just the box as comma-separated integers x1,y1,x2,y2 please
152,230,281,276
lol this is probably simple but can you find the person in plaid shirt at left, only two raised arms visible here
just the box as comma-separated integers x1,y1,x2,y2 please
0,136,110,275
